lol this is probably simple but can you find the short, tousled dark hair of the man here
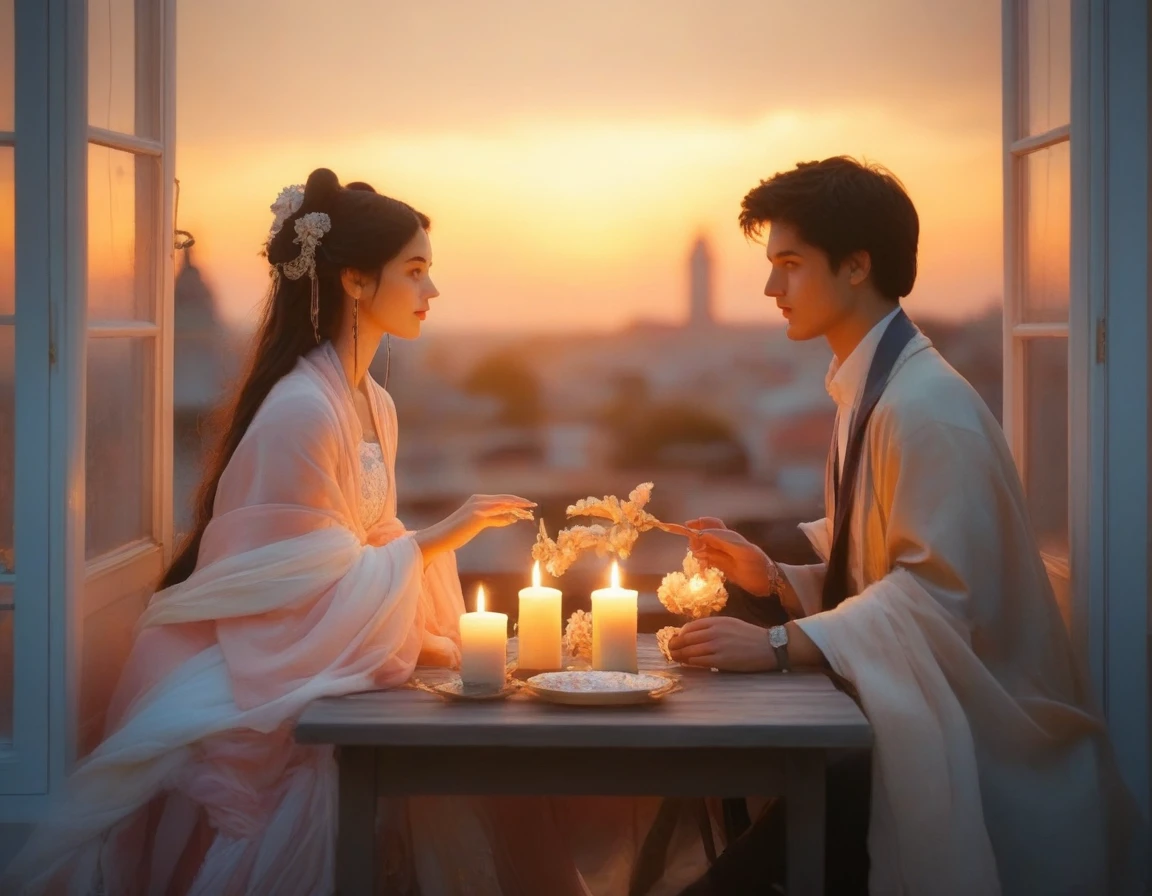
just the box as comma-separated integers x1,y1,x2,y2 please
740,155,920,302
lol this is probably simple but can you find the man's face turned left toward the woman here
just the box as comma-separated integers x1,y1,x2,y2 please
764,221,852,342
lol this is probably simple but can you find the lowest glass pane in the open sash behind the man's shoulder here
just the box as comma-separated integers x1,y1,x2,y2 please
1024,339,1068,557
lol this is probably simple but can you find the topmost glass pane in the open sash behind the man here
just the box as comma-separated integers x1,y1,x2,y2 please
1024,0,1073,135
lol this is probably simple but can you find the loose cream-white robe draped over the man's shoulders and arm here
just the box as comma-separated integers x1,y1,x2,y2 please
783,334,1143,896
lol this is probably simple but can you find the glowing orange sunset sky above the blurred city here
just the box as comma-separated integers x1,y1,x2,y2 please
167,0,1002,329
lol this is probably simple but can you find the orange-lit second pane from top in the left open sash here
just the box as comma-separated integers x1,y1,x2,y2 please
88,145,158,320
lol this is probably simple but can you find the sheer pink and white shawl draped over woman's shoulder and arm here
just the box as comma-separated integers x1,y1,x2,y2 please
142,378,424,708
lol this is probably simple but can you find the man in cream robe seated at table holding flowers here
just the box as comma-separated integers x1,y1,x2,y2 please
670,158,1142,896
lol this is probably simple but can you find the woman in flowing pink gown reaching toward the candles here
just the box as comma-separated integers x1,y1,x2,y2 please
0,168,562,896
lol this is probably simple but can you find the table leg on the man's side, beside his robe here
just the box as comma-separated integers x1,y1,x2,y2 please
785,750,825,896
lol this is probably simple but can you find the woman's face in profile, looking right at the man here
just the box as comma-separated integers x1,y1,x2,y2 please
358,227,440,339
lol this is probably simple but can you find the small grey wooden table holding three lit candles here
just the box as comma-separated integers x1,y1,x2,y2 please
296,636,871,896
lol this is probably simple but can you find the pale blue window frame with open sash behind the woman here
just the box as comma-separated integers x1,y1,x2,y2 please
0,0,175,806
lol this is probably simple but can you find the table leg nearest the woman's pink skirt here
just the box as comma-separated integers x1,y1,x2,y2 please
336,746,378,896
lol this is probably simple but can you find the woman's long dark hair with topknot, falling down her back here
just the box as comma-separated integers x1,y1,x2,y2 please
160,168,430,589
